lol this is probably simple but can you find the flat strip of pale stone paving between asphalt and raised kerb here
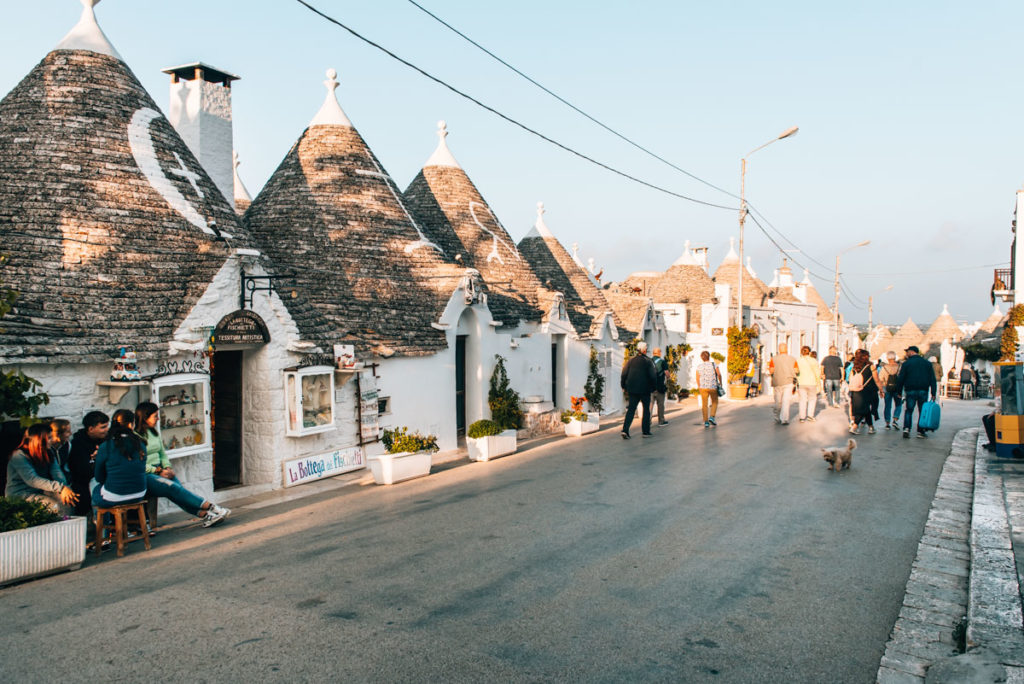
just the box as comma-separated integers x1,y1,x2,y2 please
876,428,978,684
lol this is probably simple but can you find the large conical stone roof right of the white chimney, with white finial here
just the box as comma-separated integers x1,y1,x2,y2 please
245,71,466,356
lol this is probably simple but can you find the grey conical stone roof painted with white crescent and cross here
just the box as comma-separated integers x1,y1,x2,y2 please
0,10,252,362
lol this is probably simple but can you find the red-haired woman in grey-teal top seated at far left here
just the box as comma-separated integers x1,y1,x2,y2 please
4,423,78,515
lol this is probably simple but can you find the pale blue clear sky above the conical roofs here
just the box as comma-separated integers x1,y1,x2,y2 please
0,0,1024,328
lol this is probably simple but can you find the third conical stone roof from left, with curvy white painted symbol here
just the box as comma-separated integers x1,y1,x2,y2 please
402,121,542,325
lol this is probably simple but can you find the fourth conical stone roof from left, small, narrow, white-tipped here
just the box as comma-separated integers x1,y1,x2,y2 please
519,203,622,337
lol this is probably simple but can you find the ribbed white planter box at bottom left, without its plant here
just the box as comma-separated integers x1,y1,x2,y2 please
0,517,86,585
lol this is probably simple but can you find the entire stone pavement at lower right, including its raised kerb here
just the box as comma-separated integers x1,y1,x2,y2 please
878,428,1024,684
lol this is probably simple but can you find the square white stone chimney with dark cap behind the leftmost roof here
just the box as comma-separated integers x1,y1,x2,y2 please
163,61,239,206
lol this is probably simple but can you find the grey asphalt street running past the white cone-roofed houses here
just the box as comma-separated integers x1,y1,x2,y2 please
0,399,990,682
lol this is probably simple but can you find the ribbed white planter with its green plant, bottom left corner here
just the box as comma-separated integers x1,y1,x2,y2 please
0,497,86,585
